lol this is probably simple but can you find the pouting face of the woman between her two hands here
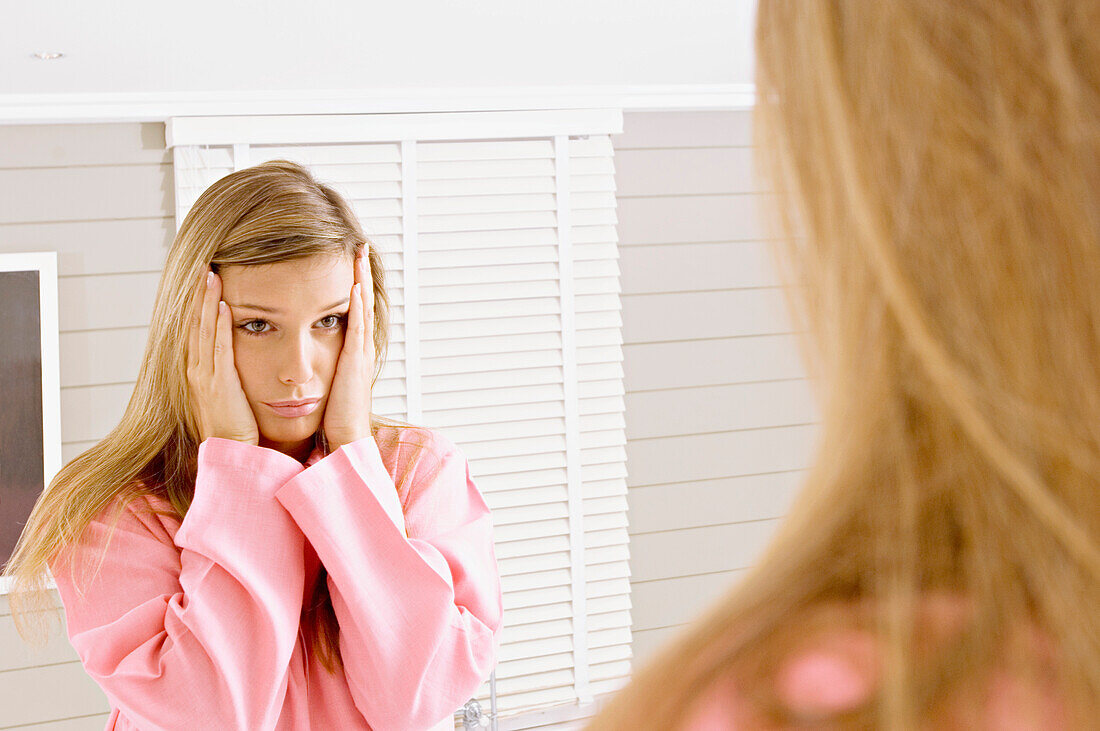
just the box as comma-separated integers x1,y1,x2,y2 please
219,255,354,457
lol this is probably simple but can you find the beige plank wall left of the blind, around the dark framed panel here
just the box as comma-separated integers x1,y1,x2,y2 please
0,123,175,731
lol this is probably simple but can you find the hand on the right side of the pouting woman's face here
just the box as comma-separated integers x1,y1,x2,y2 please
323,253,374,452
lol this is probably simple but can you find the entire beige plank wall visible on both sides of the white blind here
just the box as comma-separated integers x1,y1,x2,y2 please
0,112,816,731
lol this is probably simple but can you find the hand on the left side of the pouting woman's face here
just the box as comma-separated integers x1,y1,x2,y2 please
187,267,260,444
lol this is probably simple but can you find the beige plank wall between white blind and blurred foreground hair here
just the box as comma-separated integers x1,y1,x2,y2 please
613,111,818,667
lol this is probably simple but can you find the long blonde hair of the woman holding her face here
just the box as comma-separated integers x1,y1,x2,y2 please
4,160,424,673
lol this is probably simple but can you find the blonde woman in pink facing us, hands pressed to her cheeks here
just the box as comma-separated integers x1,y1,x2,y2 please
8,160,503,731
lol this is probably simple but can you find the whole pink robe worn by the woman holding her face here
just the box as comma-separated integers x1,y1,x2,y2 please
51,427,503,731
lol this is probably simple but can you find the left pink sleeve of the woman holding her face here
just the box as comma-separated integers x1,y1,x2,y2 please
52,438,305,731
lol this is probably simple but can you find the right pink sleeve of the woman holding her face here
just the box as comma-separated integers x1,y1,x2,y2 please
275,434,503,729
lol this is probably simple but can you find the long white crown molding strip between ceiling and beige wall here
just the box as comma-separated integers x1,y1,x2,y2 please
0,84,755,124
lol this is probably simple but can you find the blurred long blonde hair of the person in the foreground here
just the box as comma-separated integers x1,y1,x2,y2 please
587,0,1100,730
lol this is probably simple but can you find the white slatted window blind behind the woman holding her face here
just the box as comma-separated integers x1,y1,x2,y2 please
167,110,630,728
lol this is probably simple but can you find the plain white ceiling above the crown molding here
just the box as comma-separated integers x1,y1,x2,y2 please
0,0,755,115
